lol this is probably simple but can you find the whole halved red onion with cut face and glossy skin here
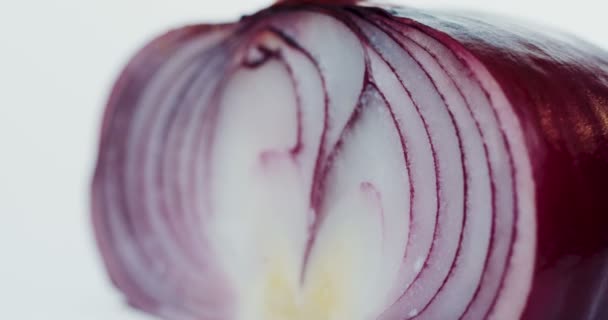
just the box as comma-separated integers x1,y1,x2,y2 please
92,1,608,320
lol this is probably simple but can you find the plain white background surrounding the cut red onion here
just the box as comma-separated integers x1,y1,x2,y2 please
0,0,608,320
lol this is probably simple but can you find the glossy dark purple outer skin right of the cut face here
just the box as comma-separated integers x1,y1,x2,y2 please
392,10,608,319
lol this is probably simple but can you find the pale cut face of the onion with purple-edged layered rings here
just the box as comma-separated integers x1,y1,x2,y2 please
94,4,576,320
